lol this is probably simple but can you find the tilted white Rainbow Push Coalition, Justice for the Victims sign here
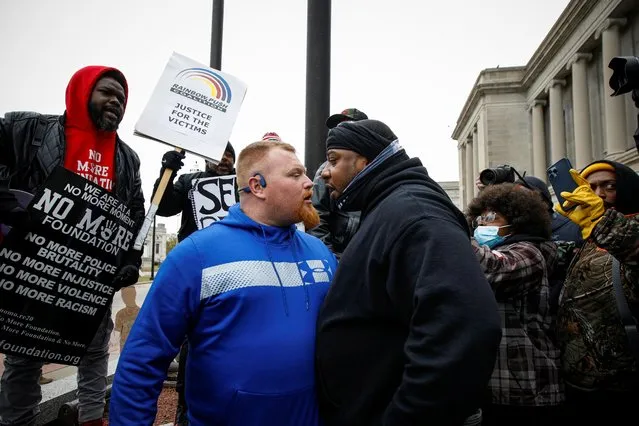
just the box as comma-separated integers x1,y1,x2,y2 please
135,53,246,161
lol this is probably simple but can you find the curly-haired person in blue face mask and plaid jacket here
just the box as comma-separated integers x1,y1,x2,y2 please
468,183,564,426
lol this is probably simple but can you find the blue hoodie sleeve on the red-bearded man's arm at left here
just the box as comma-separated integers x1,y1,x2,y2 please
109,238,202,426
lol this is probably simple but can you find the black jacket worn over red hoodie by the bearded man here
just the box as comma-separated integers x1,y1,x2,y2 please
0,112,144,265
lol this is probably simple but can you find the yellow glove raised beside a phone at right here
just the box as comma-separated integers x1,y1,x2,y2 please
555,169,605,239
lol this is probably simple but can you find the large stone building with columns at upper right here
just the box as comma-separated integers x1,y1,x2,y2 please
452,0,639,207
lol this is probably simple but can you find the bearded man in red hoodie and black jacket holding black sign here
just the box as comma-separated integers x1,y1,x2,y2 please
0,66,144,426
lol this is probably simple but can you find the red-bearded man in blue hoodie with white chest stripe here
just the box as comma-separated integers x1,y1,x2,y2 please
109,141,337,426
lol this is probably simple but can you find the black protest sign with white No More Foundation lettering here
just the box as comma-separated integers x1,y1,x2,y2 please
0,167,134,365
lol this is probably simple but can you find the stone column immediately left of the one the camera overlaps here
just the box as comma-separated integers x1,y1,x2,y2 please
567,53,592,169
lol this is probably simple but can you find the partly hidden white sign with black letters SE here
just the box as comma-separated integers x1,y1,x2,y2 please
190,175,237,229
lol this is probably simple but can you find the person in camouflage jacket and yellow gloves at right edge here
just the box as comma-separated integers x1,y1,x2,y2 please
556,160,639,424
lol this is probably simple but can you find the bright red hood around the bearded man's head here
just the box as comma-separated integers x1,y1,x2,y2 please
65,65,129,133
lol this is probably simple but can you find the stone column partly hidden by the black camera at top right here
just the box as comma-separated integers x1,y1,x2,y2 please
595,18,626,155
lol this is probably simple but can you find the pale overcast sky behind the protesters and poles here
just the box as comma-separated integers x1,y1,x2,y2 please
0,0,568,232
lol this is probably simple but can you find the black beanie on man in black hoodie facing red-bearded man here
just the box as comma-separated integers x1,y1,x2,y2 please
326,120,397,161
